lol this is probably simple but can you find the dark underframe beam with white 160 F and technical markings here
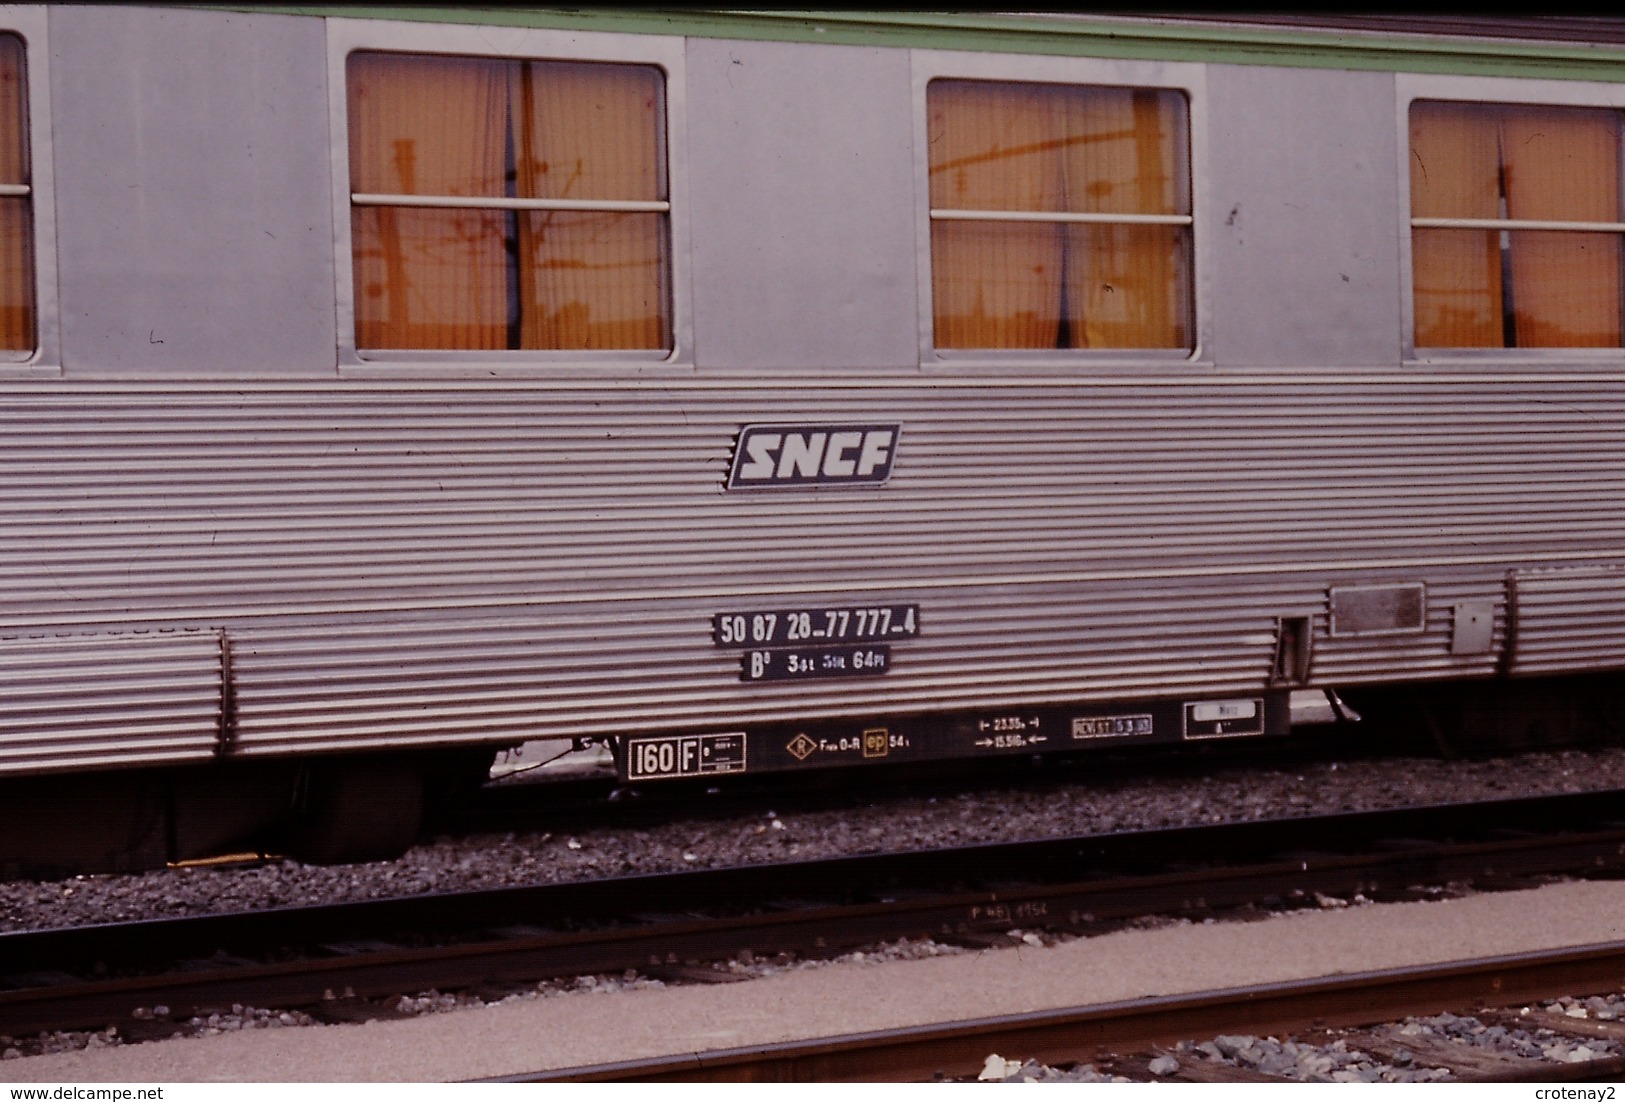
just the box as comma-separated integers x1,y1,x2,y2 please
622,691,1292,780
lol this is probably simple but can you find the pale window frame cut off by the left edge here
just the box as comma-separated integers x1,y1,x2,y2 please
0,5,62,379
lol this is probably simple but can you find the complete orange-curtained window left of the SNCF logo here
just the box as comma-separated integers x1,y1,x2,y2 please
348,52,671,349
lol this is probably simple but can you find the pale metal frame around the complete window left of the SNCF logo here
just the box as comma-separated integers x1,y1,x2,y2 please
327,18,694,377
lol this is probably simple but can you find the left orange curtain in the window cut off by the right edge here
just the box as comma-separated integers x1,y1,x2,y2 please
1411,104,1503,348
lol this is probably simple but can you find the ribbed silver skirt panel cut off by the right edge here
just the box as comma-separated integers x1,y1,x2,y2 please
1510,566,1625,675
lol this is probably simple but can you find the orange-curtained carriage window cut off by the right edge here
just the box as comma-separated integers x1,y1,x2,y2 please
1411,101,1625,348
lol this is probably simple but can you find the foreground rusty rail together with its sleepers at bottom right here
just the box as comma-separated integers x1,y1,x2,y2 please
520,941,1625,1082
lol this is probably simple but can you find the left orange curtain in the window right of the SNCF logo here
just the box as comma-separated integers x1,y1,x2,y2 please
928,81,1064,348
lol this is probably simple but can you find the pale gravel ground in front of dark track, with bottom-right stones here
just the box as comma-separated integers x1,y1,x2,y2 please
15,881,1625,1082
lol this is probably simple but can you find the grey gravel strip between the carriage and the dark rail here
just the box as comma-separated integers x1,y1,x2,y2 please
0,748,1625,931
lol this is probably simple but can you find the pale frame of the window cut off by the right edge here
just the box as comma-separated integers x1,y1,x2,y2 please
1394,73,1625,367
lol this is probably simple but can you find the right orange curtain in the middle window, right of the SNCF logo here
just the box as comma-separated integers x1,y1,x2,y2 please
1060,88,1190,348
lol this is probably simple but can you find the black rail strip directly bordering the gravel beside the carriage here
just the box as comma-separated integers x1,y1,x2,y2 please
19,790,1625,977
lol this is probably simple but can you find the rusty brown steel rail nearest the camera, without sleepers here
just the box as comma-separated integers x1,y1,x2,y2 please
510,941,1625,1082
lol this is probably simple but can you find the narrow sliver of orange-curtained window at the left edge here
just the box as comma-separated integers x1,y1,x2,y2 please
0,34,37,351
